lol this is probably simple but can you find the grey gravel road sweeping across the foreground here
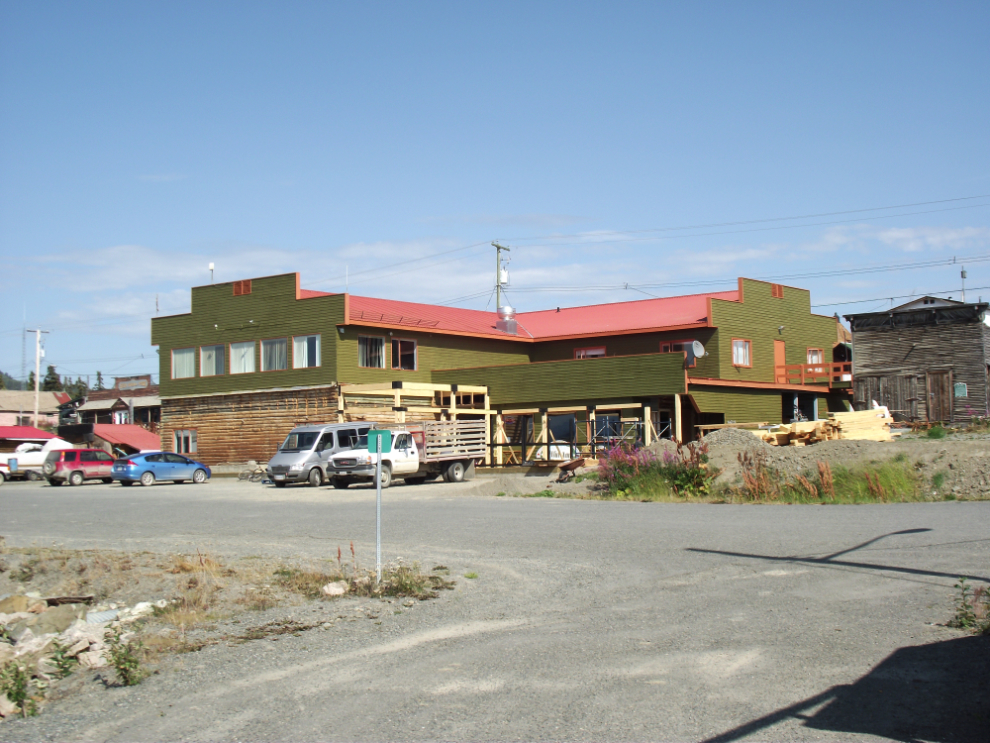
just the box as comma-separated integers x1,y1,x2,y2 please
0,478,990,743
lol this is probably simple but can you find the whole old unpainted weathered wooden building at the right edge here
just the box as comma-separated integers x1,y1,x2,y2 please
845,297,990,423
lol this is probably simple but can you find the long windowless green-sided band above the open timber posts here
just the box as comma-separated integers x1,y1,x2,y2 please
433,353,684,406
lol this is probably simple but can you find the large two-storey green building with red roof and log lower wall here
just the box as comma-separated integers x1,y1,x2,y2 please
152,274,849,464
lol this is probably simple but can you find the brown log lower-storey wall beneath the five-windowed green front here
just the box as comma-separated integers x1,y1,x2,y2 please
161,385,339,465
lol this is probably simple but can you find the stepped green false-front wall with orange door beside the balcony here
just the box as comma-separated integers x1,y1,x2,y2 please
708,279,837,382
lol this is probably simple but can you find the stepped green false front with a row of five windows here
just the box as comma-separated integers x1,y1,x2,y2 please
151,274,344,397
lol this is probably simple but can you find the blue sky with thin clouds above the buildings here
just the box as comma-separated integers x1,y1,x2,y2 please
0,0,990,390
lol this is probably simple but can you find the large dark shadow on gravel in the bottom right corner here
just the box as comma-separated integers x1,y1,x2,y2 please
704,636,990,743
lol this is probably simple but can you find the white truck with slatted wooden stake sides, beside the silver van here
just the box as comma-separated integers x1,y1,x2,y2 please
327,420,488,488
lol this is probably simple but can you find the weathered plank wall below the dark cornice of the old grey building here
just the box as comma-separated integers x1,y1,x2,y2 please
853,321,990,423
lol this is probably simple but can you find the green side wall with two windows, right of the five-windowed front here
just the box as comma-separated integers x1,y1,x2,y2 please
337,325,530,384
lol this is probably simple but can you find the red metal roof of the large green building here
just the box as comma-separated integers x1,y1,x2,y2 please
348,291,739,341
